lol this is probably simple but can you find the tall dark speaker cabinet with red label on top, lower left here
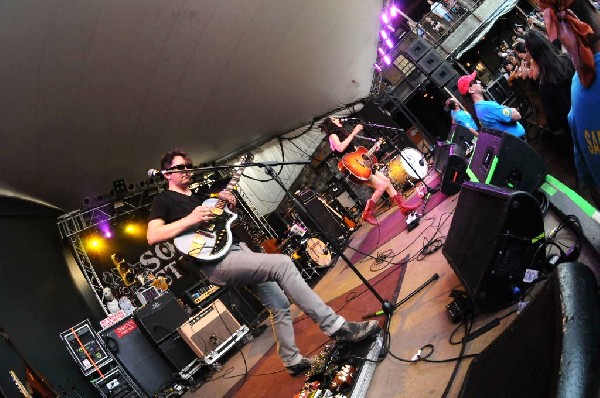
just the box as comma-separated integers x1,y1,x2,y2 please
100,317,173,397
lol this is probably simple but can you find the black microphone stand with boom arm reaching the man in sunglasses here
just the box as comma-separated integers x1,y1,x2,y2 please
183,161,395,319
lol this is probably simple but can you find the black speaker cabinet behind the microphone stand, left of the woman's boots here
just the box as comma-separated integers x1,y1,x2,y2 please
296,189,344,240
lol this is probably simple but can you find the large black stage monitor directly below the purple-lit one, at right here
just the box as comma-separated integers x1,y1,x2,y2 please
442,182,544,309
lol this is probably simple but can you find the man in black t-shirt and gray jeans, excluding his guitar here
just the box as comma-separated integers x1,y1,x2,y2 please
147,150,379,376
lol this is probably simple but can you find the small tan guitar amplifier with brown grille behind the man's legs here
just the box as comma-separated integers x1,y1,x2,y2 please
177,300,240,358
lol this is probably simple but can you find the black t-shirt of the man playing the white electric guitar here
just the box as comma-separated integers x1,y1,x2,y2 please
148,190,208,224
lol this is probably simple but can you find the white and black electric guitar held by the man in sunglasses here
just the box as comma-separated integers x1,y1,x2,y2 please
174,156,250,261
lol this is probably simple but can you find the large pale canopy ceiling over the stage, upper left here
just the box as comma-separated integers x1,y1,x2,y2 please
0,0,382,210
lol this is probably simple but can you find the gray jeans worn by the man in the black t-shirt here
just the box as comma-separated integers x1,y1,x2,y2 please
200,243,345,366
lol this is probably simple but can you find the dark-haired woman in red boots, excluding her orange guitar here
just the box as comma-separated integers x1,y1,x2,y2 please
319,117,420,225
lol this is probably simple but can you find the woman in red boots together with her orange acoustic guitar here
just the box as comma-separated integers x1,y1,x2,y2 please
319,117,420,225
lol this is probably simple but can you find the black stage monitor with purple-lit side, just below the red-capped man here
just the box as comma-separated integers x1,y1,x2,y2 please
469,129,547,192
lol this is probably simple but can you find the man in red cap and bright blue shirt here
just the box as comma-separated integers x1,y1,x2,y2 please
458,72,525,137
